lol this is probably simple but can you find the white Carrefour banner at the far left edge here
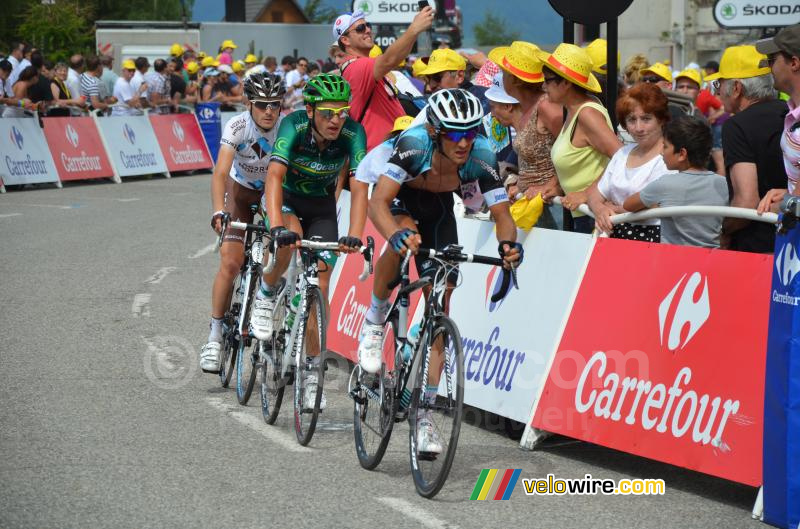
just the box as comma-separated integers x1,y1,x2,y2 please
0,118,58,186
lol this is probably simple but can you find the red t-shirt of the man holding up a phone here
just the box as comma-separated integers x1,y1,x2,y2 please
342,57,405,150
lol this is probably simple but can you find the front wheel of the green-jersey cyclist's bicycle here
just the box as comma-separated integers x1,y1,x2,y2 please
294,287,327,446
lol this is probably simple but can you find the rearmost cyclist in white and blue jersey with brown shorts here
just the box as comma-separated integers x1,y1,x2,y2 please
200,72,286,373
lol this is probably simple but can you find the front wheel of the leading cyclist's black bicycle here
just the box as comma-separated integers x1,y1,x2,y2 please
408,314,464,498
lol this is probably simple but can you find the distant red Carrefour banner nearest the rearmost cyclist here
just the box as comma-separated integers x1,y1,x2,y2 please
149,114,214,172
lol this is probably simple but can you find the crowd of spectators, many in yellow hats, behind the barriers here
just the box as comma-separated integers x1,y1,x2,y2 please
0,20,800,253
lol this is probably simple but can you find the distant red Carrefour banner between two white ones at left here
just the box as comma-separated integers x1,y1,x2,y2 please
42,117,114,181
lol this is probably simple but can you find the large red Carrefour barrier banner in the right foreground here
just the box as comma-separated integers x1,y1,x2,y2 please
532,239,772,486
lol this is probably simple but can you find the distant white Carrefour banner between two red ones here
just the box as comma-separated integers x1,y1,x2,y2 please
97,116,167,176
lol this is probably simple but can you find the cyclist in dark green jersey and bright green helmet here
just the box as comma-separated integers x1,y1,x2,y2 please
250,74,368,407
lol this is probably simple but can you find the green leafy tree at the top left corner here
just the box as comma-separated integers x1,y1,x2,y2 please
17,0,94,61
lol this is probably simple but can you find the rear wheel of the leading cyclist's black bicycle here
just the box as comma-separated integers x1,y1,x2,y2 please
351,319,402,470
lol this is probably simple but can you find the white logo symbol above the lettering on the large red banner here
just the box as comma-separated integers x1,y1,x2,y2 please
658,272,711,351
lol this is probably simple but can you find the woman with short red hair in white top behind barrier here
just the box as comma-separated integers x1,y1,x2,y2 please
588,83,670,242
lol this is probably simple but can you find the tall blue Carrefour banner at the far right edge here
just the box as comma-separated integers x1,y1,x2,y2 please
764,218,800,529
